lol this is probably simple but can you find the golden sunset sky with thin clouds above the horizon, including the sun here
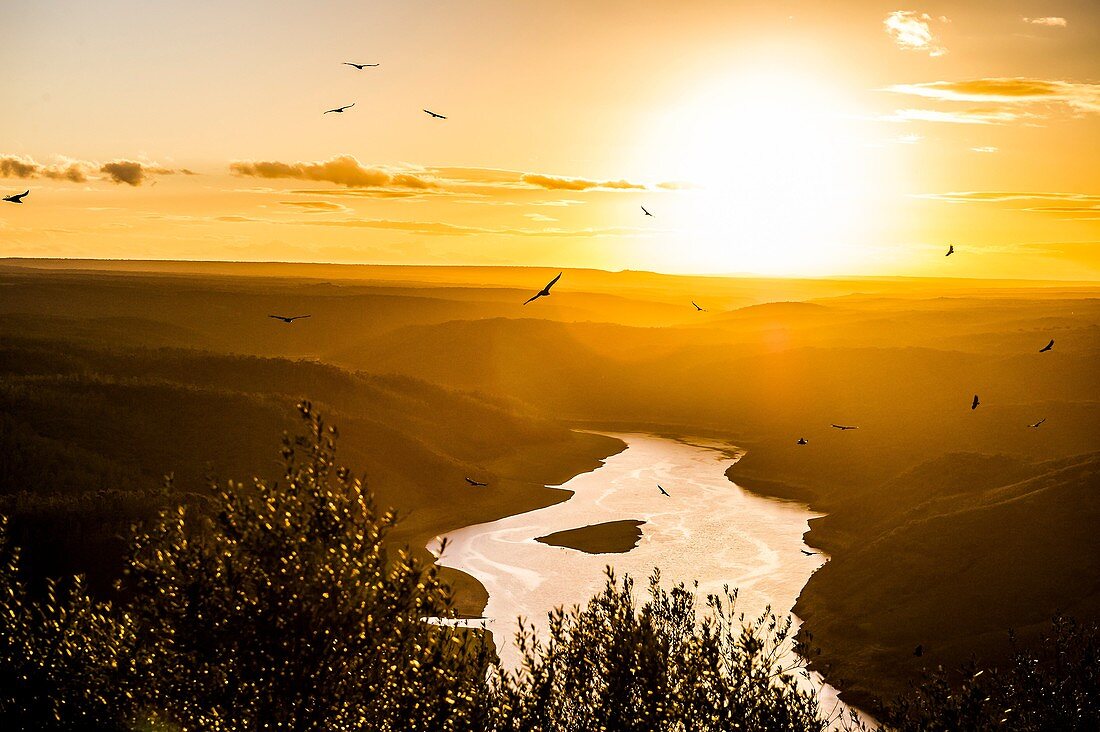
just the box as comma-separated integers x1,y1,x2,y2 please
0,0,1100,281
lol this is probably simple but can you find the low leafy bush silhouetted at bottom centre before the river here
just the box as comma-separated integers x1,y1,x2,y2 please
494,570,844,732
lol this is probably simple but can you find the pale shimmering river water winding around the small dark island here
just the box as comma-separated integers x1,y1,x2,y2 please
431,434,853,711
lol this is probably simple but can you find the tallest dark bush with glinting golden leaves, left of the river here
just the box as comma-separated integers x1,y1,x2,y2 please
127,402,491,730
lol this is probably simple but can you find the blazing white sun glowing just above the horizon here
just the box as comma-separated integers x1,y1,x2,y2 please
647,69,872,275
